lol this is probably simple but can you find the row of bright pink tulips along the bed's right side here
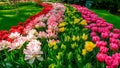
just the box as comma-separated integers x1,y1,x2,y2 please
72,5,120,68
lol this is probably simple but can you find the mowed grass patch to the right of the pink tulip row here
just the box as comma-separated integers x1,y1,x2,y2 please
92,9,120,29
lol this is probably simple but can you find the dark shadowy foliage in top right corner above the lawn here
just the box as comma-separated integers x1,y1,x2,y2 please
93,0,120,12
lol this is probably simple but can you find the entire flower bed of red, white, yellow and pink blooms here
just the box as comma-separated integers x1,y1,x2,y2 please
0,3,120,68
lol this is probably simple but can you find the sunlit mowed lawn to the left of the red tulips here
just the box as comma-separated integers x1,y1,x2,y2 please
0,4,42,30
